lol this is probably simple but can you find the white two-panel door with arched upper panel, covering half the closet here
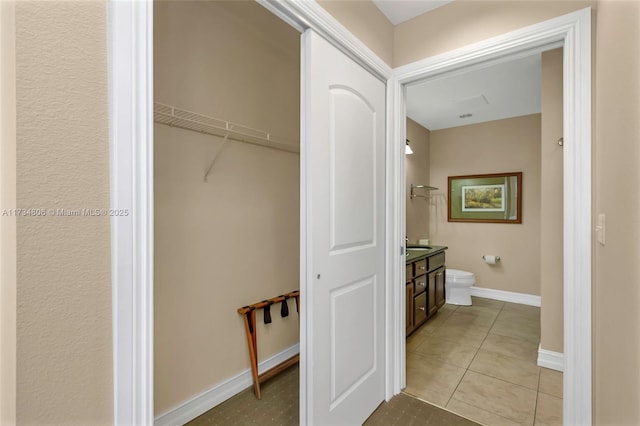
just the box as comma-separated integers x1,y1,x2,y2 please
301,30,386,425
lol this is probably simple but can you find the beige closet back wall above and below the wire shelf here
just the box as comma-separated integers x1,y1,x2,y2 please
154,1,300,415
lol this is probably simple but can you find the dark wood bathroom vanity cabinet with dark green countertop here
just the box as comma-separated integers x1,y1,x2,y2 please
406,246,447,336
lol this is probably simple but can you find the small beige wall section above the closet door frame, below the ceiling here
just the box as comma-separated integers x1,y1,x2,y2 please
318,0,394,66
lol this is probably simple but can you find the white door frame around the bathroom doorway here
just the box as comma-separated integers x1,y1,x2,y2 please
393,8,592,425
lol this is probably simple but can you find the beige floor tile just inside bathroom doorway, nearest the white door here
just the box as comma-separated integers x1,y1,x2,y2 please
404,354,465,407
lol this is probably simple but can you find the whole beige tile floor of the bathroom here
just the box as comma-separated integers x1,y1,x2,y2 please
404,297,562,426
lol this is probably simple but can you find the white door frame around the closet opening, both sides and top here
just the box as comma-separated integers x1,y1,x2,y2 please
107,0,396,426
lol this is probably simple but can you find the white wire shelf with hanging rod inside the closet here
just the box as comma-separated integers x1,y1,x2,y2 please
153,102,300,154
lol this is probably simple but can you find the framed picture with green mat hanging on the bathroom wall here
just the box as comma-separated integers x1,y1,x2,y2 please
447,172,522,224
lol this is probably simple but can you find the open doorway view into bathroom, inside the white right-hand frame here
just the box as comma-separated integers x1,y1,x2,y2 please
405,49,562,423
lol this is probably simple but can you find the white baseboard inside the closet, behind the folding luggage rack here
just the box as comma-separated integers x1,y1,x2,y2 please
154,343,300,426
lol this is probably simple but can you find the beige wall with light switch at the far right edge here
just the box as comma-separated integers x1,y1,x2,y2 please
593,1,640,425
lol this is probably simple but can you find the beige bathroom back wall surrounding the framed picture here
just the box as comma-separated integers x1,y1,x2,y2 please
429,114,540,295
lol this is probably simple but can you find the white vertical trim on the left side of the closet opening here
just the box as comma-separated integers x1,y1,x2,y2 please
107,0,153,426
